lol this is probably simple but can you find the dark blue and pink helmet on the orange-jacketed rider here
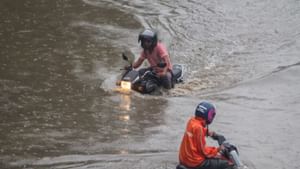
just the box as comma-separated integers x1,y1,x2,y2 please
195,101,216,124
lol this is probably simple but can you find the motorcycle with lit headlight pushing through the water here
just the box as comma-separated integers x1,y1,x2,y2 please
116,53,183,94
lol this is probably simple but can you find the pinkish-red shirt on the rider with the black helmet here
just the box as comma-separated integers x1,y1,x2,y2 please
139,42,172,73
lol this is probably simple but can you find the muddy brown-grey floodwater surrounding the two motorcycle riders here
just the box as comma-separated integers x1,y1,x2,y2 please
0,0,300,169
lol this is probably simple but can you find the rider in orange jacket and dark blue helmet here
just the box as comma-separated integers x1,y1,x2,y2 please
179,102,233,169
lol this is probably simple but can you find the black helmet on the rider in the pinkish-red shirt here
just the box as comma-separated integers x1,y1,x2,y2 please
138,29,157,50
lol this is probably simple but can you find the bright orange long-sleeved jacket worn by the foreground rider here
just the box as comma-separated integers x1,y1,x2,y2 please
179,117,219,167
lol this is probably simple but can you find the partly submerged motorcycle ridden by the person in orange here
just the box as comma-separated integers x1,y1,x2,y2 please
176,134,247,169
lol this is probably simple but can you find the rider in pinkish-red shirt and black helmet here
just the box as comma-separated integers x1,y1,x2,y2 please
132,29,172,89
